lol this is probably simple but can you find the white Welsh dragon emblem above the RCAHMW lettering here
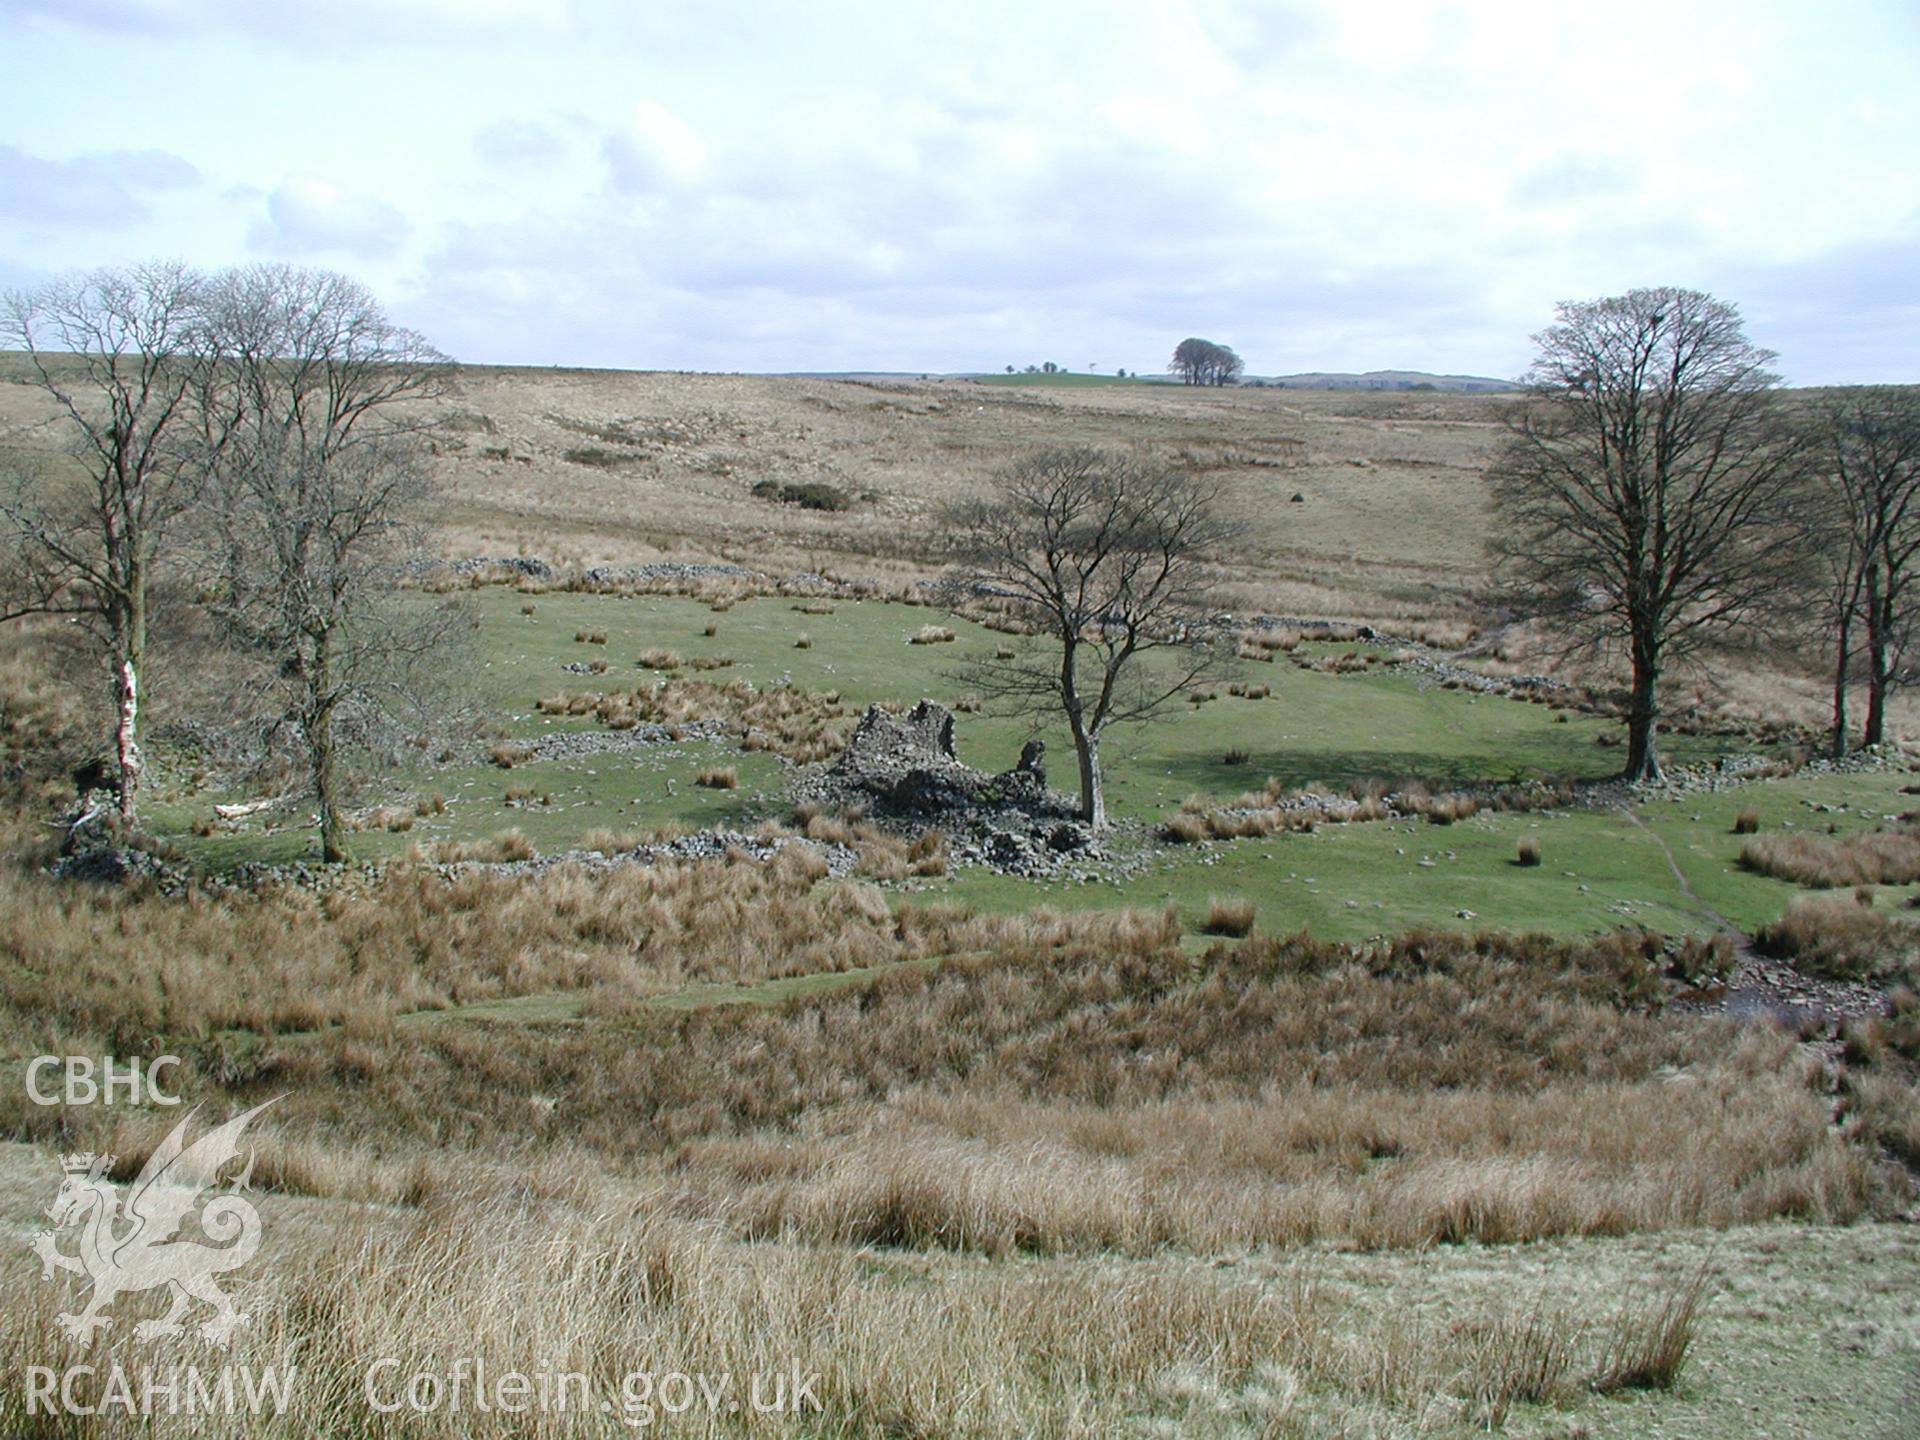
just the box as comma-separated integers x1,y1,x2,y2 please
31,1096,280,1346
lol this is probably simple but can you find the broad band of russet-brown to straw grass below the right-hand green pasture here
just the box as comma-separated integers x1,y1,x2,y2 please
56,917,1858,1254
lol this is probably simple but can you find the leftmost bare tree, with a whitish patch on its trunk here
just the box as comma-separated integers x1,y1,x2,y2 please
0,263,209,824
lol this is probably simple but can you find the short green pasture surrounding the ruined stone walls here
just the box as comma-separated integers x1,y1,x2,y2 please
152,588,1908,939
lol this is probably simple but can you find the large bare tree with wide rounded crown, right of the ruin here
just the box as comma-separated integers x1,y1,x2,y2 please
1492,288,1811,780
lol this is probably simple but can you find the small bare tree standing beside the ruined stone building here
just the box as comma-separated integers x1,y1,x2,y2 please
948,449,1233,828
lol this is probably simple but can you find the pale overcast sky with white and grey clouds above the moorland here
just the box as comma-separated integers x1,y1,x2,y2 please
0,0,1920,384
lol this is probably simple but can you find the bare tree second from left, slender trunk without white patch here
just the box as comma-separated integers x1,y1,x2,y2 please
207,267,463,862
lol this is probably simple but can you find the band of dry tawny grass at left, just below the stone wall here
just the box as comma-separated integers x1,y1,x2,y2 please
0,831,1020,1052
